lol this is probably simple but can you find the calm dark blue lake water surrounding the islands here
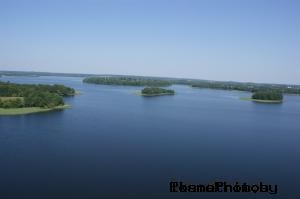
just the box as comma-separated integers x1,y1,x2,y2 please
0,77,300,199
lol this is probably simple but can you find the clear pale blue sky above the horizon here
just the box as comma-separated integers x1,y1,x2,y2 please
0,0,300,84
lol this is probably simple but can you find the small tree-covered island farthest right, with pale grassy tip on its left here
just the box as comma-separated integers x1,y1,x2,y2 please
241,90,283,103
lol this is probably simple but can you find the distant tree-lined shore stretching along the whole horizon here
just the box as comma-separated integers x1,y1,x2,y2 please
0,71,300,96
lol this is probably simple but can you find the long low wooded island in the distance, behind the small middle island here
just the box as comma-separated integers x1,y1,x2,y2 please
83,76,171,86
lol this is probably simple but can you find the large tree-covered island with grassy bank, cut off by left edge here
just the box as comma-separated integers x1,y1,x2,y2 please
0,82,75,115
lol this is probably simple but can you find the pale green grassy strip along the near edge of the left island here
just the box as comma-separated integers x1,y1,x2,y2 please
0,105,71,116
